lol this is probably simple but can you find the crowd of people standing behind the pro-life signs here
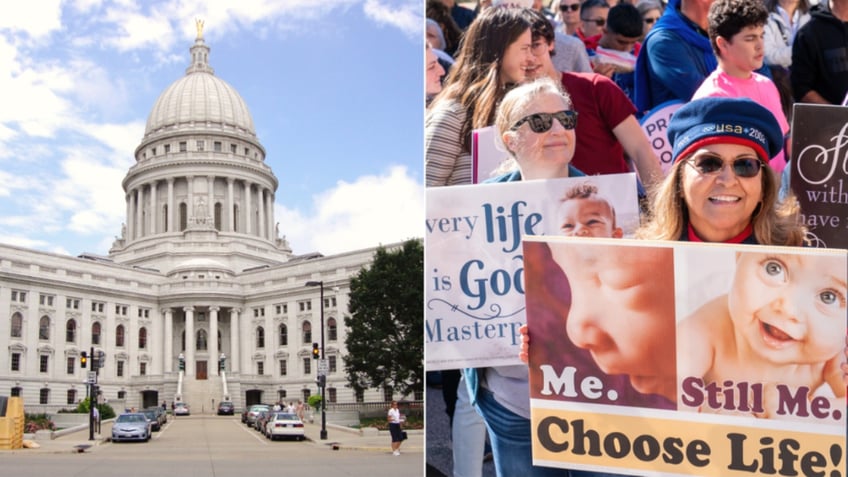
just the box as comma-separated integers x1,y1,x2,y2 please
424,0,848,477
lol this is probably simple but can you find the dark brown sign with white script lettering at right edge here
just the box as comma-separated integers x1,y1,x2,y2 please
790,103,848,248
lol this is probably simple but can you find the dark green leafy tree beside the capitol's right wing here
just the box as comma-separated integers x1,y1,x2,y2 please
344,239,424,394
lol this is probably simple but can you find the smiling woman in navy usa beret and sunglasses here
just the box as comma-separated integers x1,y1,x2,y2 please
638,98,805,246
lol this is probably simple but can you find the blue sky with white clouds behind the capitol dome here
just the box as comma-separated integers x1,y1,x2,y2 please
0,0,424,255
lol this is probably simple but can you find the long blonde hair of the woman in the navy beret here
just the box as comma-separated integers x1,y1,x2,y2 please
636,157,807,246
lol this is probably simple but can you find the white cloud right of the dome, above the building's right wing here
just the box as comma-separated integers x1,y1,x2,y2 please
275,166,424,255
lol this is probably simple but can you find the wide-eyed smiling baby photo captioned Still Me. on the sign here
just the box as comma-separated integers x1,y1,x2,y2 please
677,247,848,425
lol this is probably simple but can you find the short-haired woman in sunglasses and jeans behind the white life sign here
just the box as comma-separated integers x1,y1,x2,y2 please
464,77,628,477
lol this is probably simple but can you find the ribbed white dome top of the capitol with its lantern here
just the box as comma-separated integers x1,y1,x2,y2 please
142,37,256,143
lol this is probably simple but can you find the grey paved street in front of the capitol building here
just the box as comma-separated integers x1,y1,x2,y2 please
0,416,424,477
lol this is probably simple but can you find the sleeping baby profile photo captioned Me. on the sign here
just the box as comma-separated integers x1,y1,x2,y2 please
524,239,677,410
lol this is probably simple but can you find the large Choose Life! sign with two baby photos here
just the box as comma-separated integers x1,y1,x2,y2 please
523,237,848,477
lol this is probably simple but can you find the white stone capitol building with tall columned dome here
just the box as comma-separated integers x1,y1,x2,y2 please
0,31,410,413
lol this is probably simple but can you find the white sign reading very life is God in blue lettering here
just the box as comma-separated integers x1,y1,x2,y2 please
424,173,639,370
